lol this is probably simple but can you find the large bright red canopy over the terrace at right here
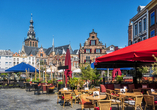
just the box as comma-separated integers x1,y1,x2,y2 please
95,36,157,68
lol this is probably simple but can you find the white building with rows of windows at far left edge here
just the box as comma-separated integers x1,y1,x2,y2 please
0,50,13,69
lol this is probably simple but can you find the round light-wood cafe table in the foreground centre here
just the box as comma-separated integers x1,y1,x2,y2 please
86,95,106,106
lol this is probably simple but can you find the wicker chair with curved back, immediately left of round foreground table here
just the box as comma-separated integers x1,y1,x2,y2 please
80,94,95,110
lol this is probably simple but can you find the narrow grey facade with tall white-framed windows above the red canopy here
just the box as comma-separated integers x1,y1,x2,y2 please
128,6,149,45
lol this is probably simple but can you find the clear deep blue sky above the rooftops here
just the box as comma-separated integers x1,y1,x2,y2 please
0,0,151,52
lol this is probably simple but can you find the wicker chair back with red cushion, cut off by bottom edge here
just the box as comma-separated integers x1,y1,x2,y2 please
94,100,112,110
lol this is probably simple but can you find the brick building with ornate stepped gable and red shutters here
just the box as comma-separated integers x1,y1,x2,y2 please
79,29,106,64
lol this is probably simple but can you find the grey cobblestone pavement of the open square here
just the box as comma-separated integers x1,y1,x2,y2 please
0,88,145,110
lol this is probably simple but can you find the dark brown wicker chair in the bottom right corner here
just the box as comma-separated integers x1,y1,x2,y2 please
143,95,157,110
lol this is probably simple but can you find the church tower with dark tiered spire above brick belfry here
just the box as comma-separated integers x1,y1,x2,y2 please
24,14,38,47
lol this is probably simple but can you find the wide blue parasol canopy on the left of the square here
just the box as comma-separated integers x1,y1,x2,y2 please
5,62,39,73
